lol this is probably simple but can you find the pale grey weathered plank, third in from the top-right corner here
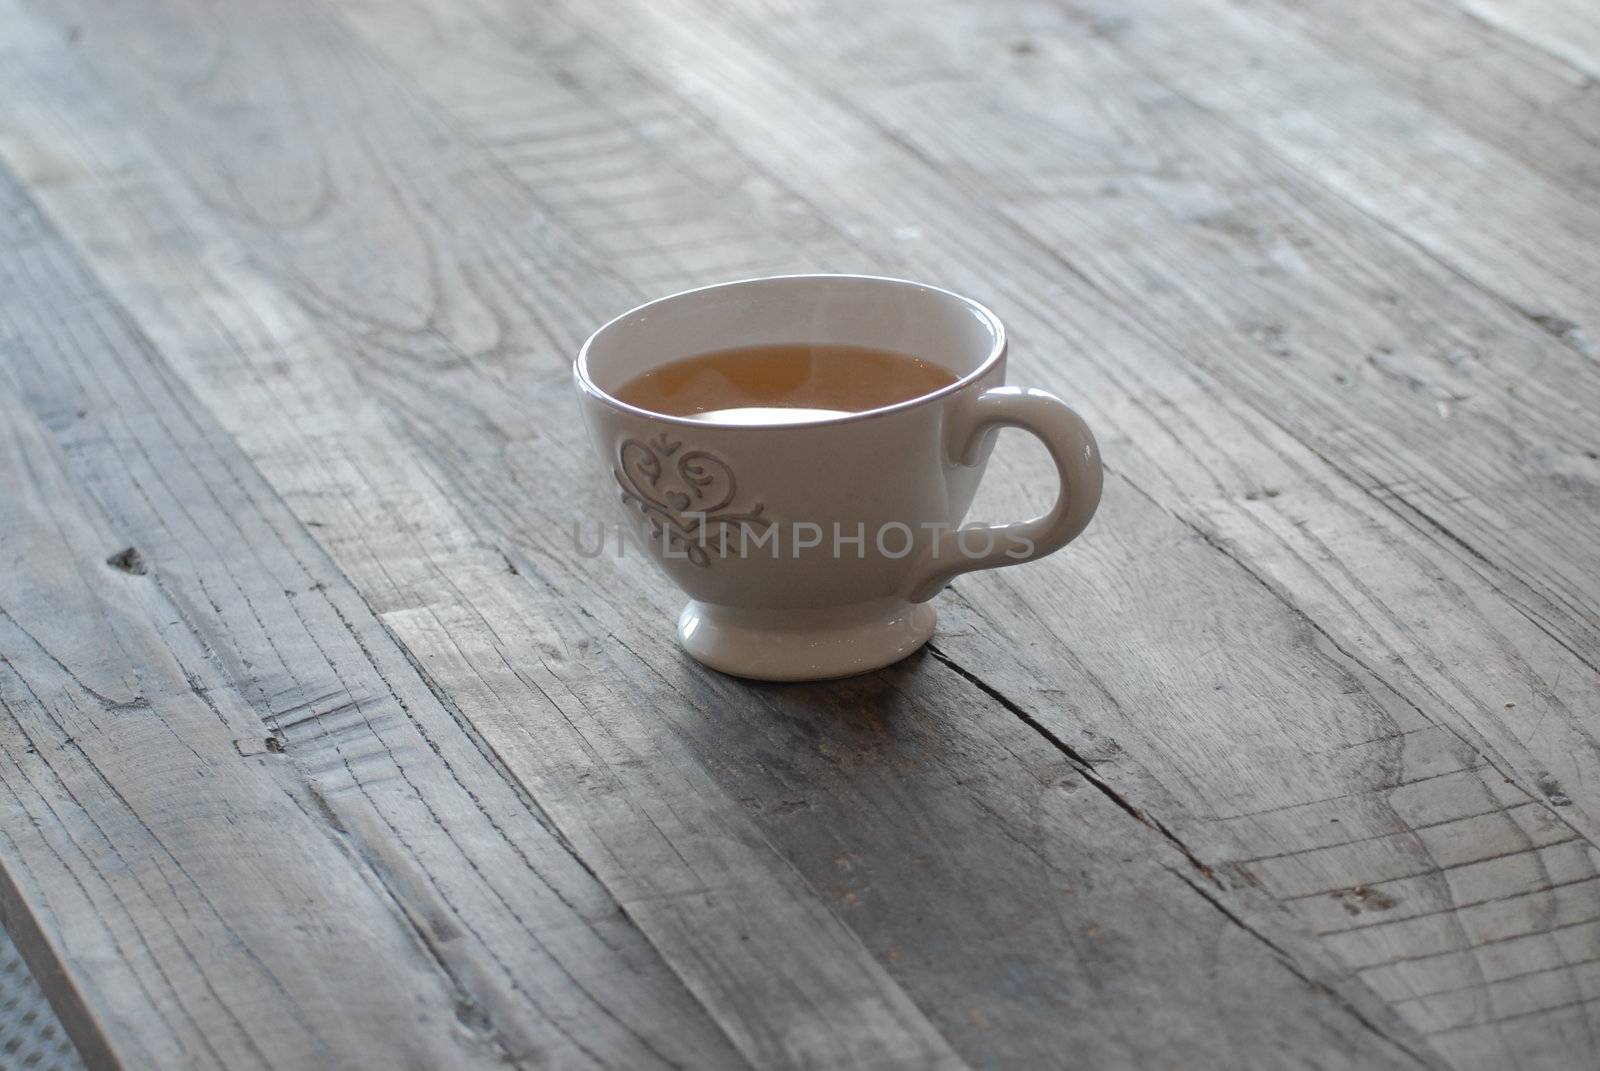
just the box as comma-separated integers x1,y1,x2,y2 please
1080,0,1600,337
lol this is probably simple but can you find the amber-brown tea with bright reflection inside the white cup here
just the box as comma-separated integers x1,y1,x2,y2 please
614,343,957,424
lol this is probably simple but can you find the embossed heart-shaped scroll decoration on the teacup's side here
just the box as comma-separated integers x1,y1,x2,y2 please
613,432,773,568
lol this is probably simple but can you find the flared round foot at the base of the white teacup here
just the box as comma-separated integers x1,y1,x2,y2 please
678,599,936,680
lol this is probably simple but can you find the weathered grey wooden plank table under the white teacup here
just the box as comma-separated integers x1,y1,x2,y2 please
0,0,1600,1069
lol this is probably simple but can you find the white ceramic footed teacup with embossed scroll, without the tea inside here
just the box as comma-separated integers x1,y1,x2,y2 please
574,275,1101,680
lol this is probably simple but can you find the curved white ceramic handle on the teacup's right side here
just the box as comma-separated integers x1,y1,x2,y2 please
907,387,1104,602
